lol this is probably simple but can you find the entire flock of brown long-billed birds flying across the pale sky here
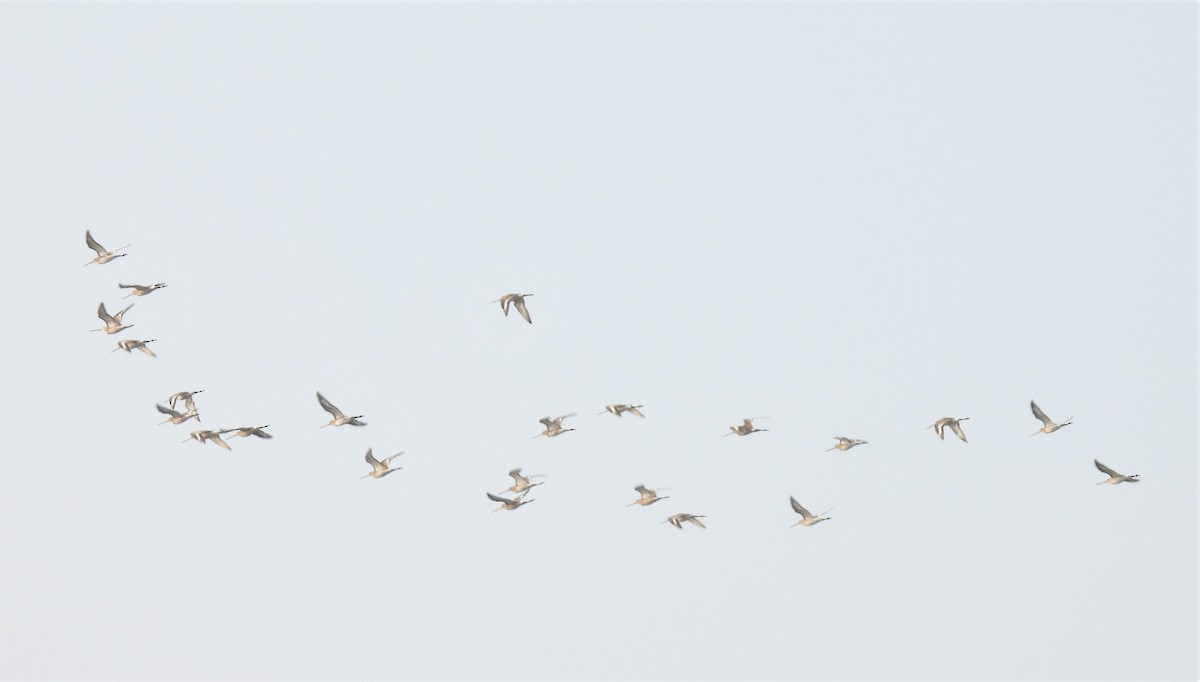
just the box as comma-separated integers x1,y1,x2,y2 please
84,231,1139,530
